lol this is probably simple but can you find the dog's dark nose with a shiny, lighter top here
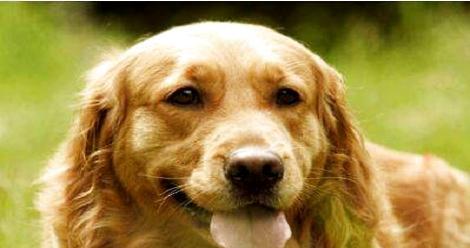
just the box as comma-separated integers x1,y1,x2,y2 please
225,148,284,193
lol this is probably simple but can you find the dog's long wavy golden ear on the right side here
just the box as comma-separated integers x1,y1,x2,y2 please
308,55,378,244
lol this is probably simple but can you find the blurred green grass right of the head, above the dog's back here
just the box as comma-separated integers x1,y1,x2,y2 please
327,3,470,170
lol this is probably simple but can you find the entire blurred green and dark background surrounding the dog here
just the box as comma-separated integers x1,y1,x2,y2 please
0,3,470,247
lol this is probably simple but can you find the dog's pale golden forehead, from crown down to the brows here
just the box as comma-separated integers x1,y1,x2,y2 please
126,23,312,92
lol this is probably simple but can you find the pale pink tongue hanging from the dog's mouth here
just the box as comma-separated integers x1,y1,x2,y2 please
211,207,291,248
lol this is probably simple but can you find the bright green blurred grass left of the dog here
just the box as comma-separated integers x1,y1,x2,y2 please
0,3,126,247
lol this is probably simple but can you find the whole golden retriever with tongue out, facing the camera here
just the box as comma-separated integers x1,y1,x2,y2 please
37,22,470,248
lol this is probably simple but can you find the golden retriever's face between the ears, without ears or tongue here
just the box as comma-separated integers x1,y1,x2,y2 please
104,23,338,240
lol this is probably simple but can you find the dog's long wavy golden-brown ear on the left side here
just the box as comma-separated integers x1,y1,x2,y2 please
61,59,126,247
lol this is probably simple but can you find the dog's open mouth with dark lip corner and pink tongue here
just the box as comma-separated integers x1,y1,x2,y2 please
162,180,291,248
